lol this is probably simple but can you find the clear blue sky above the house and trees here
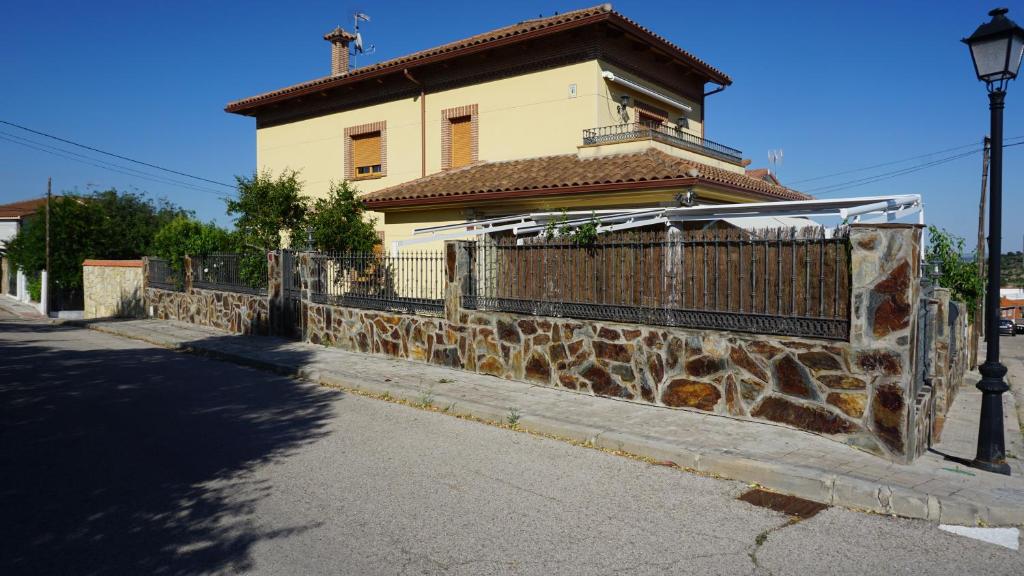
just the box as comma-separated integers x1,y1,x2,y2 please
0,0,1024,250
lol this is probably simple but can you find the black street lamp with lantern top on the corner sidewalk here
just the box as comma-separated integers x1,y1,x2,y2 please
964,8,1024,476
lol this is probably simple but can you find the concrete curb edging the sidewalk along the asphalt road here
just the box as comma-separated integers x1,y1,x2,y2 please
79,322,1024,526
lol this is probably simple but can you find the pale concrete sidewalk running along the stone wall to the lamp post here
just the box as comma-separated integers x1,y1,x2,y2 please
77,320,1024,526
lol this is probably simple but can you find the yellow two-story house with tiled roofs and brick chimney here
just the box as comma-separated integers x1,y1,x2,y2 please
226,4,808,248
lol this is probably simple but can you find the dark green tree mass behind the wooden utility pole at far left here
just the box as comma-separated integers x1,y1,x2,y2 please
7,190,188,290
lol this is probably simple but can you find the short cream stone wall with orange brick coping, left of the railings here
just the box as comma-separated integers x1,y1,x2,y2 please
82,260,143,319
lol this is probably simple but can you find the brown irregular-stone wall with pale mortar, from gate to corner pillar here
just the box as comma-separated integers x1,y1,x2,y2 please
306,224,933,461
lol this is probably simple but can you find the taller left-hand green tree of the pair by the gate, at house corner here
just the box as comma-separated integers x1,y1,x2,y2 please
226,170,306,253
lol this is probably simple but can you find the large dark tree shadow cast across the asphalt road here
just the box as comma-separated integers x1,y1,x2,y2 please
0,323,340,575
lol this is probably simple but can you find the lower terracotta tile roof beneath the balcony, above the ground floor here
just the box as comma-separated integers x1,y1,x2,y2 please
362,149,810,208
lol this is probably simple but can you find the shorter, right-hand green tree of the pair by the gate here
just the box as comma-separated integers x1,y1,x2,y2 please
306,180,380,252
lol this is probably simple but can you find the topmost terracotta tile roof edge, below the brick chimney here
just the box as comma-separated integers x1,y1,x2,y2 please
224,4,732,113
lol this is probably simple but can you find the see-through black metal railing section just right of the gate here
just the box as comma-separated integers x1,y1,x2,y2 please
309,251,444,316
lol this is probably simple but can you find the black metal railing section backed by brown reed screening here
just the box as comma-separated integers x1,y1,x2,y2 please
463,228,850,339
